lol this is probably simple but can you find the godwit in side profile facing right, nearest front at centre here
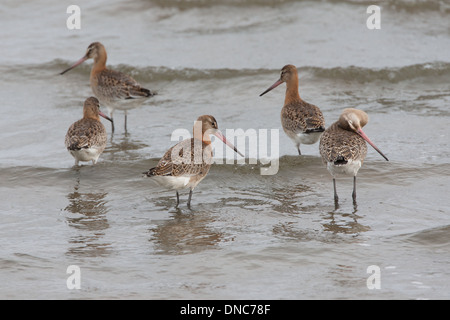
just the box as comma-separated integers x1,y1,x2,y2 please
144,115,243,207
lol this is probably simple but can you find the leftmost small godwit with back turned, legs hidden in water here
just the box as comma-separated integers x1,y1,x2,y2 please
65,97,111,166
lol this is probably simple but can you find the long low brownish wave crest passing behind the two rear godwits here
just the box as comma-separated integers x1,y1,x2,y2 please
6,59,450,83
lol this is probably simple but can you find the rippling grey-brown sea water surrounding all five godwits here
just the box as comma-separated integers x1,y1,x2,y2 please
0,0,450,299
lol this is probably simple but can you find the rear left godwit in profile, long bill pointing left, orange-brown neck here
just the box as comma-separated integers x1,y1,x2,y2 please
61,42,154,132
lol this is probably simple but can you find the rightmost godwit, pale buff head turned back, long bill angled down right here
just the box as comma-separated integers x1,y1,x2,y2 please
319,108,389,204
